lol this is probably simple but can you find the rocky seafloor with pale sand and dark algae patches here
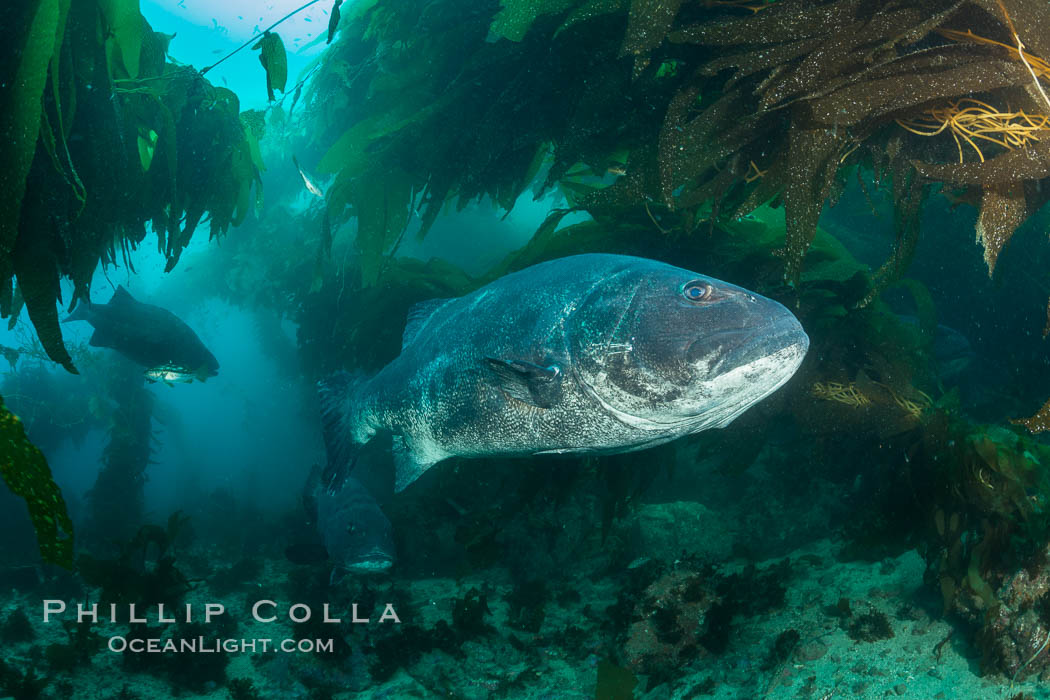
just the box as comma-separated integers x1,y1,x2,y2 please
0,493,1050,700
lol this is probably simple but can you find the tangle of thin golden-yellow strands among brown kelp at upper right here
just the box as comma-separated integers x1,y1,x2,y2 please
897,98,1050,163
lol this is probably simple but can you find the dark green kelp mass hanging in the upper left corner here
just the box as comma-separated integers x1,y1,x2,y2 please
0,0,261,372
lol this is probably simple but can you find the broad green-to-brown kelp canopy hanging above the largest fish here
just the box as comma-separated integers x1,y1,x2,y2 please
310,0,1050,304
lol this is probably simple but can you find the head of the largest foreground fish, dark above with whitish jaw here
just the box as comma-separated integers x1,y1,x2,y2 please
569,261,810,434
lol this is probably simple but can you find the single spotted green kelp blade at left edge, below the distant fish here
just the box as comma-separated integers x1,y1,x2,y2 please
0,398,72,569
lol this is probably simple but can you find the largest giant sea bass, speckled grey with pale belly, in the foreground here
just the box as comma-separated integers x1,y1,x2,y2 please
320,255,810,490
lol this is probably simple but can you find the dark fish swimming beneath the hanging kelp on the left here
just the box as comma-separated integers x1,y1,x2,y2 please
65,287,218,381
